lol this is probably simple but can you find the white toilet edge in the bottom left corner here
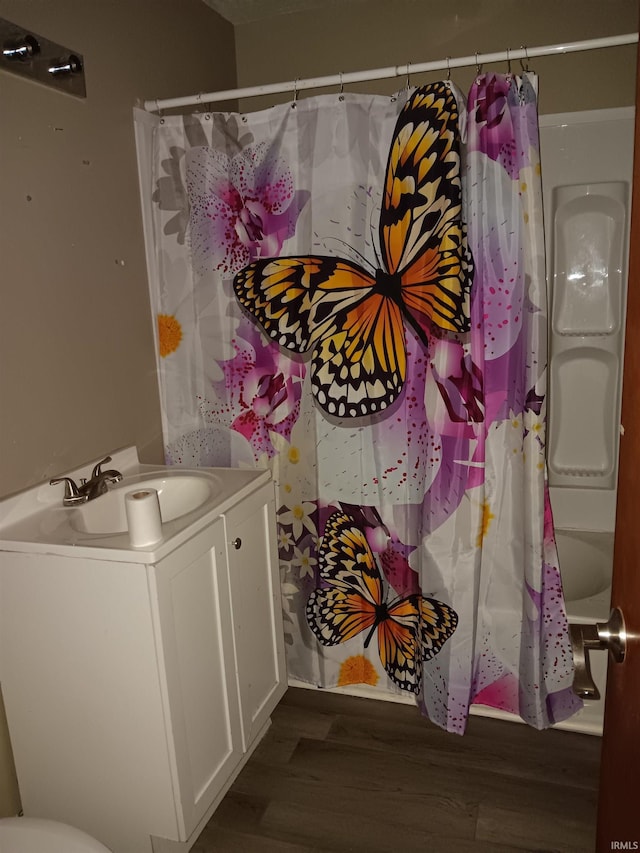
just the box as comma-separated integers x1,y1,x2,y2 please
0,817,110,853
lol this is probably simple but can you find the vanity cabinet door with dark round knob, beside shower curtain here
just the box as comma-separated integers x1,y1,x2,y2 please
225,483,287,750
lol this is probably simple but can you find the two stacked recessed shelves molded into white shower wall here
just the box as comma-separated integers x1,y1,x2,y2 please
548,181,628,489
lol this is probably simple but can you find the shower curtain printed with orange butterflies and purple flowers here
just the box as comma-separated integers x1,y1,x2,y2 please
136,74,581,733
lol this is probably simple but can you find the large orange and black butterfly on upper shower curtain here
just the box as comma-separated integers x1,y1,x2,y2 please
233,83,473,418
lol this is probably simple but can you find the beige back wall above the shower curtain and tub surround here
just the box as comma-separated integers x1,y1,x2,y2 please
236,0,639,113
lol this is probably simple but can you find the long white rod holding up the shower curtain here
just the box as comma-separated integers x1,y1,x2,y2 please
144,33,638,113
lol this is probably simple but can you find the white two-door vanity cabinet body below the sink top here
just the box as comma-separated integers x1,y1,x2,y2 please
0,472,286,853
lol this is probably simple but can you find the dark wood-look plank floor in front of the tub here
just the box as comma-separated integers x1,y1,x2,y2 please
192,688,600,853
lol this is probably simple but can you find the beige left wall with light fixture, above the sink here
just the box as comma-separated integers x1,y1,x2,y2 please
0,0,236,816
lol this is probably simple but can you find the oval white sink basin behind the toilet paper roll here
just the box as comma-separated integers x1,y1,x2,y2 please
70,473,215,535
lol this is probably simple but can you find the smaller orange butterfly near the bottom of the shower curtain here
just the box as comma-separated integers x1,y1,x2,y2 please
306,512,458,693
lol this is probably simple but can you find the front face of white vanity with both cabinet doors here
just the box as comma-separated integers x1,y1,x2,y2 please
150,484,286,839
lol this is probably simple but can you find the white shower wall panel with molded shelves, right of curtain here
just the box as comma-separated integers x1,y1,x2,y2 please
540,108,634,532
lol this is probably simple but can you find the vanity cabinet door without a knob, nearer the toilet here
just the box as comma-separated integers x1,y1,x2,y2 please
151,518,242,841
